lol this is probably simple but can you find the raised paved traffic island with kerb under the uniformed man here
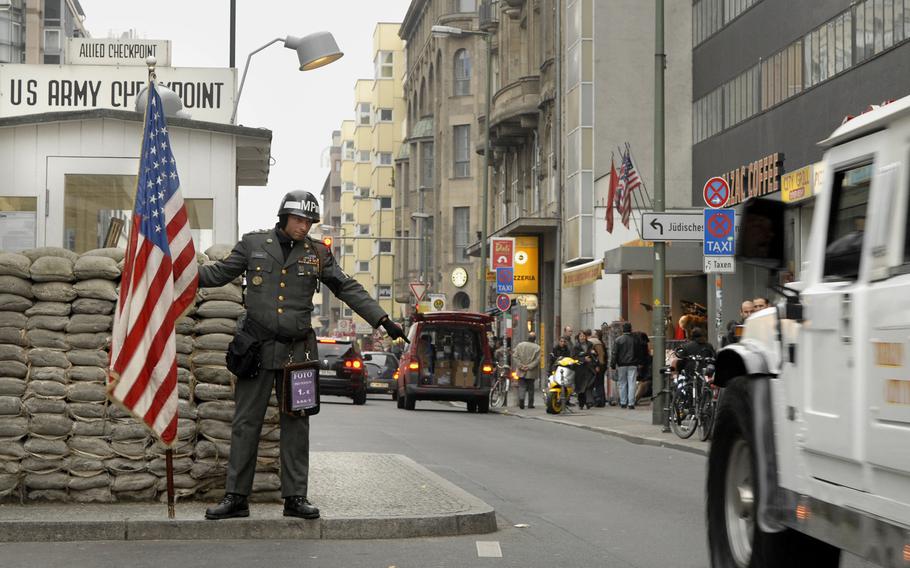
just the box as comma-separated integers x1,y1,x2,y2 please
0,452,496,542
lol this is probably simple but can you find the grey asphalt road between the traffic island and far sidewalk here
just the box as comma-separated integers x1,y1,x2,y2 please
0,398,876,568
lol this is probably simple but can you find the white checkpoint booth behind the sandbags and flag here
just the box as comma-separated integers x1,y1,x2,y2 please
0,108,272,253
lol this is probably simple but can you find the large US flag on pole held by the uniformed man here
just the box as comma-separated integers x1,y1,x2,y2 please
108,82,198,445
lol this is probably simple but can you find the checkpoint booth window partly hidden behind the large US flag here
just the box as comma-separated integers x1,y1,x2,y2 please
63,174,214,253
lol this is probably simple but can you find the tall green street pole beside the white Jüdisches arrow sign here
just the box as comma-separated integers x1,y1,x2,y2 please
651,0,667,425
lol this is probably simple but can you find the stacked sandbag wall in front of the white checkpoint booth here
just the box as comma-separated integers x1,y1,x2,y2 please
0,246,280,502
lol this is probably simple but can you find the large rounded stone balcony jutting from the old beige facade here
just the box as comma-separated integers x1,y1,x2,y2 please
490,75,540,146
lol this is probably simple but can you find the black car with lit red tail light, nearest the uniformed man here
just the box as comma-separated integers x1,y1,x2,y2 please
318,337,368,404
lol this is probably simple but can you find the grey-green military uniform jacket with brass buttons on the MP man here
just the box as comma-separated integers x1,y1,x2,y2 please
199,229,386,369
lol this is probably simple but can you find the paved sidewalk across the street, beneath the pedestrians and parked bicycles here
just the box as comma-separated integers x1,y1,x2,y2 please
493,391,710,456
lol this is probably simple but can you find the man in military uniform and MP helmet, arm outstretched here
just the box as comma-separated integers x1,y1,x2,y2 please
205,191,405,519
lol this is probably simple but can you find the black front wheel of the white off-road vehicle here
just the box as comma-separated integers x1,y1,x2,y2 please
707,377,840,568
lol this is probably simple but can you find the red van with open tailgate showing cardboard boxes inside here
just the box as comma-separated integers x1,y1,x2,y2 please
398,312,495,412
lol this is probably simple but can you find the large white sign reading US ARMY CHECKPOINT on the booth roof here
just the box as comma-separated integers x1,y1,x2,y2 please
0,64,237,123
